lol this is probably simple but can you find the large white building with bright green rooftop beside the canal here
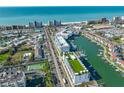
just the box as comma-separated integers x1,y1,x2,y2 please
63,53,90,85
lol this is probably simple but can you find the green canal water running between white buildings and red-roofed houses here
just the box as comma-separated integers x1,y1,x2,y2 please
74,36,124,87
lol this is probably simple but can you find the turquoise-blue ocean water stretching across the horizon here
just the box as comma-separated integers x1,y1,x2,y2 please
0,6,124,25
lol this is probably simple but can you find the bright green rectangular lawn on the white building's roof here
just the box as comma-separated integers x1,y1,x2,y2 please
69,59,84,73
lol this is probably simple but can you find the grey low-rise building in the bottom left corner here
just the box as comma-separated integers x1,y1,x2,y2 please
0,68,26,87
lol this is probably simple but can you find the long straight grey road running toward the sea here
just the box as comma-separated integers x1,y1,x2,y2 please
44,27,65,87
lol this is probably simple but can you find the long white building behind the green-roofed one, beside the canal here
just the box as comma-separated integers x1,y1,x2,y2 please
55,35,70,52
